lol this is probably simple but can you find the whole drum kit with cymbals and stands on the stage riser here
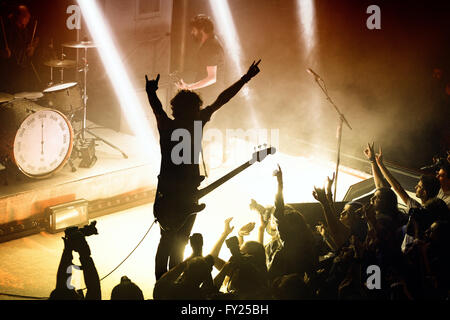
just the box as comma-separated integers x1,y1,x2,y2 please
0,41,128,183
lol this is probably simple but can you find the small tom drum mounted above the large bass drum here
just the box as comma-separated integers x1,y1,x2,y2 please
40,82,83,115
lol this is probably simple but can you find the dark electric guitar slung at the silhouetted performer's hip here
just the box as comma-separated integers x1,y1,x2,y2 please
153,147,276,231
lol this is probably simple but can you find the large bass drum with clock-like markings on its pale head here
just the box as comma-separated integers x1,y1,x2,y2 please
0,99,73,179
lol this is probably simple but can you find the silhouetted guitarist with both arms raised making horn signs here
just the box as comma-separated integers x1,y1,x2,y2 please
145,60,261,280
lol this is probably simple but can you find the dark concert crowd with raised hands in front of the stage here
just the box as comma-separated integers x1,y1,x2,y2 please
50,144,450,300
